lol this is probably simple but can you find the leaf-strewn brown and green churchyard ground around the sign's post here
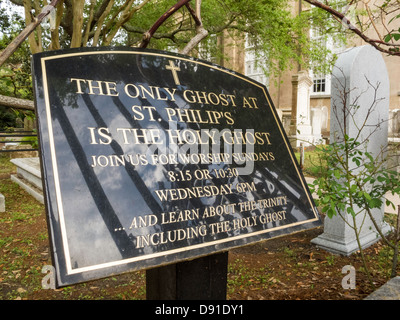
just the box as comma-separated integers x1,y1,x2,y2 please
0,175,390,300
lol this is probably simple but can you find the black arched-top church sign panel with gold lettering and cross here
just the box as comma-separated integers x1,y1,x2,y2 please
33,48,321,286
